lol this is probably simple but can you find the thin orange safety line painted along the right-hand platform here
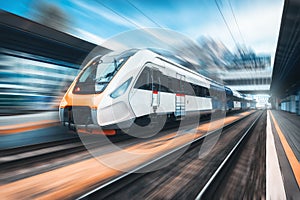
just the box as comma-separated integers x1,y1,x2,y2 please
270,111,300,187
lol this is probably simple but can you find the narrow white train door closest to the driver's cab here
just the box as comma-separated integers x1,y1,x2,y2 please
151,68,162,112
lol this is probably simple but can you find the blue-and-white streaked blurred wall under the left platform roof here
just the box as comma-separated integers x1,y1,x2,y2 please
0,49,77,115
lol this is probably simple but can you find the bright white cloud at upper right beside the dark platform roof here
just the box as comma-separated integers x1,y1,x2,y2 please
190,1,283,56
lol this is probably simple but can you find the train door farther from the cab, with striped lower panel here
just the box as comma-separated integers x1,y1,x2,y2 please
175,73,186,117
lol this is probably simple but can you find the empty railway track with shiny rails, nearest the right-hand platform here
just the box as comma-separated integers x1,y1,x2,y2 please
77,112,261,199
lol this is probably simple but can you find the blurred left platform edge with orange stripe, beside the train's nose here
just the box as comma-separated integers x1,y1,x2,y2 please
0,111,74,149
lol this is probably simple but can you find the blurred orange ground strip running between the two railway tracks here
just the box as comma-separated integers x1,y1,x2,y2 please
0,111,254,199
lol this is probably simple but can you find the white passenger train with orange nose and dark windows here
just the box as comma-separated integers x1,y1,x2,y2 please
59,49,255,135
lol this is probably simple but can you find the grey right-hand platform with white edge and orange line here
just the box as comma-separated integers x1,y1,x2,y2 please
266,110,300,199
